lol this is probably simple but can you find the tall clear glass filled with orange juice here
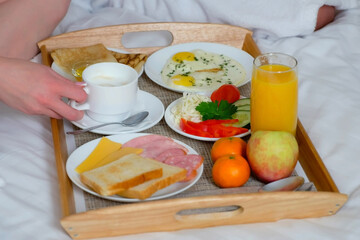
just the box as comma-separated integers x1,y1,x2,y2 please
250,53,298,135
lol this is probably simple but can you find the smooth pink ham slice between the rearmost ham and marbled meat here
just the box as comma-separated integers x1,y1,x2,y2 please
140,139,188,159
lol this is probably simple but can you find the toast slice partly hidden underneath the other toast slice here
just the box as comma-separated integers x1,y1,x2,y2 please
118,162,187,200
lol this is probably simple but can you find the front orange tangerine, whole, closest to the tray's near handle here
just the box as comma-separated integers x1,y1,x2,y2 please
212,154,250,188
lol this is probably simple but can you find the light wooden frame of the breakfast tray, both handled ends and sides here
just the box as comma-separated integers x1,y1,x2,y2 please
38,23,347,239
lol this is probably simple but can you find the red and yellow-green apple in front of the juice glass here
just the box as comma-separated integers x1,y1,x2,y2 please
246,131,299,183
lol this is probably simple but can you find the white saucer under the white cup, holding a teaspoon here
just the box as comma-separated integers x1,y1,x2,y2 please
71,90,165,135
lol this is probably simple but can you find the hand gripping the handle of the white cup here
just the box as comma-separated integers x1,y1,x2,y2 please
0,58,87,121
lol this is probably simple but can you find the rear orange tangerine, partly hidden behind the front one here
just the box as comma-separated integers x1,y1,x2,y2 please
210,137,246,162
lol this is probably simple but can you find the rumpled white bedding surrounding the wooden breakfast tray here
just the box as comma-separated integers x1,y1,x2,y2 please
0,0,360,240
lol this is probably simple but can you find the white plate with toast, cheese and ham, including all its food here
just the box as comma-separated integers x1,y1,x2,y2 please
66,133,203,202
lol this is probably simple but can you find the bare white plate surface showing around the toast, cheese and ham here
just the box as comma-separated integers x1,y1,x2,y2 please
66,133,204,202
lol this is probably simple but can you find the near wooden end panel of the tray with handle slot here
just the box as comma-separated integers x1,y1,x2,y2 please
61,192,347,239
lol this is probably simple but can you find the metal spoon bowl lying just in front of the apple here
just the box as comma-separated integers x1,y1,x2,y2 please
259,176,304,192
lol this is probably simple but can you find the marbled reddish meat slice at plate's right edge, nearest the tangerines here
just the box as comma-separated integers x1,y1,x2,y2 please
164,154,204,181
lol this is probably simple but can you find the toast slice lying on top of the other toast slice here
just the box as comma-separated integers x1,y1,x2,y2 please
80,154,163,196
